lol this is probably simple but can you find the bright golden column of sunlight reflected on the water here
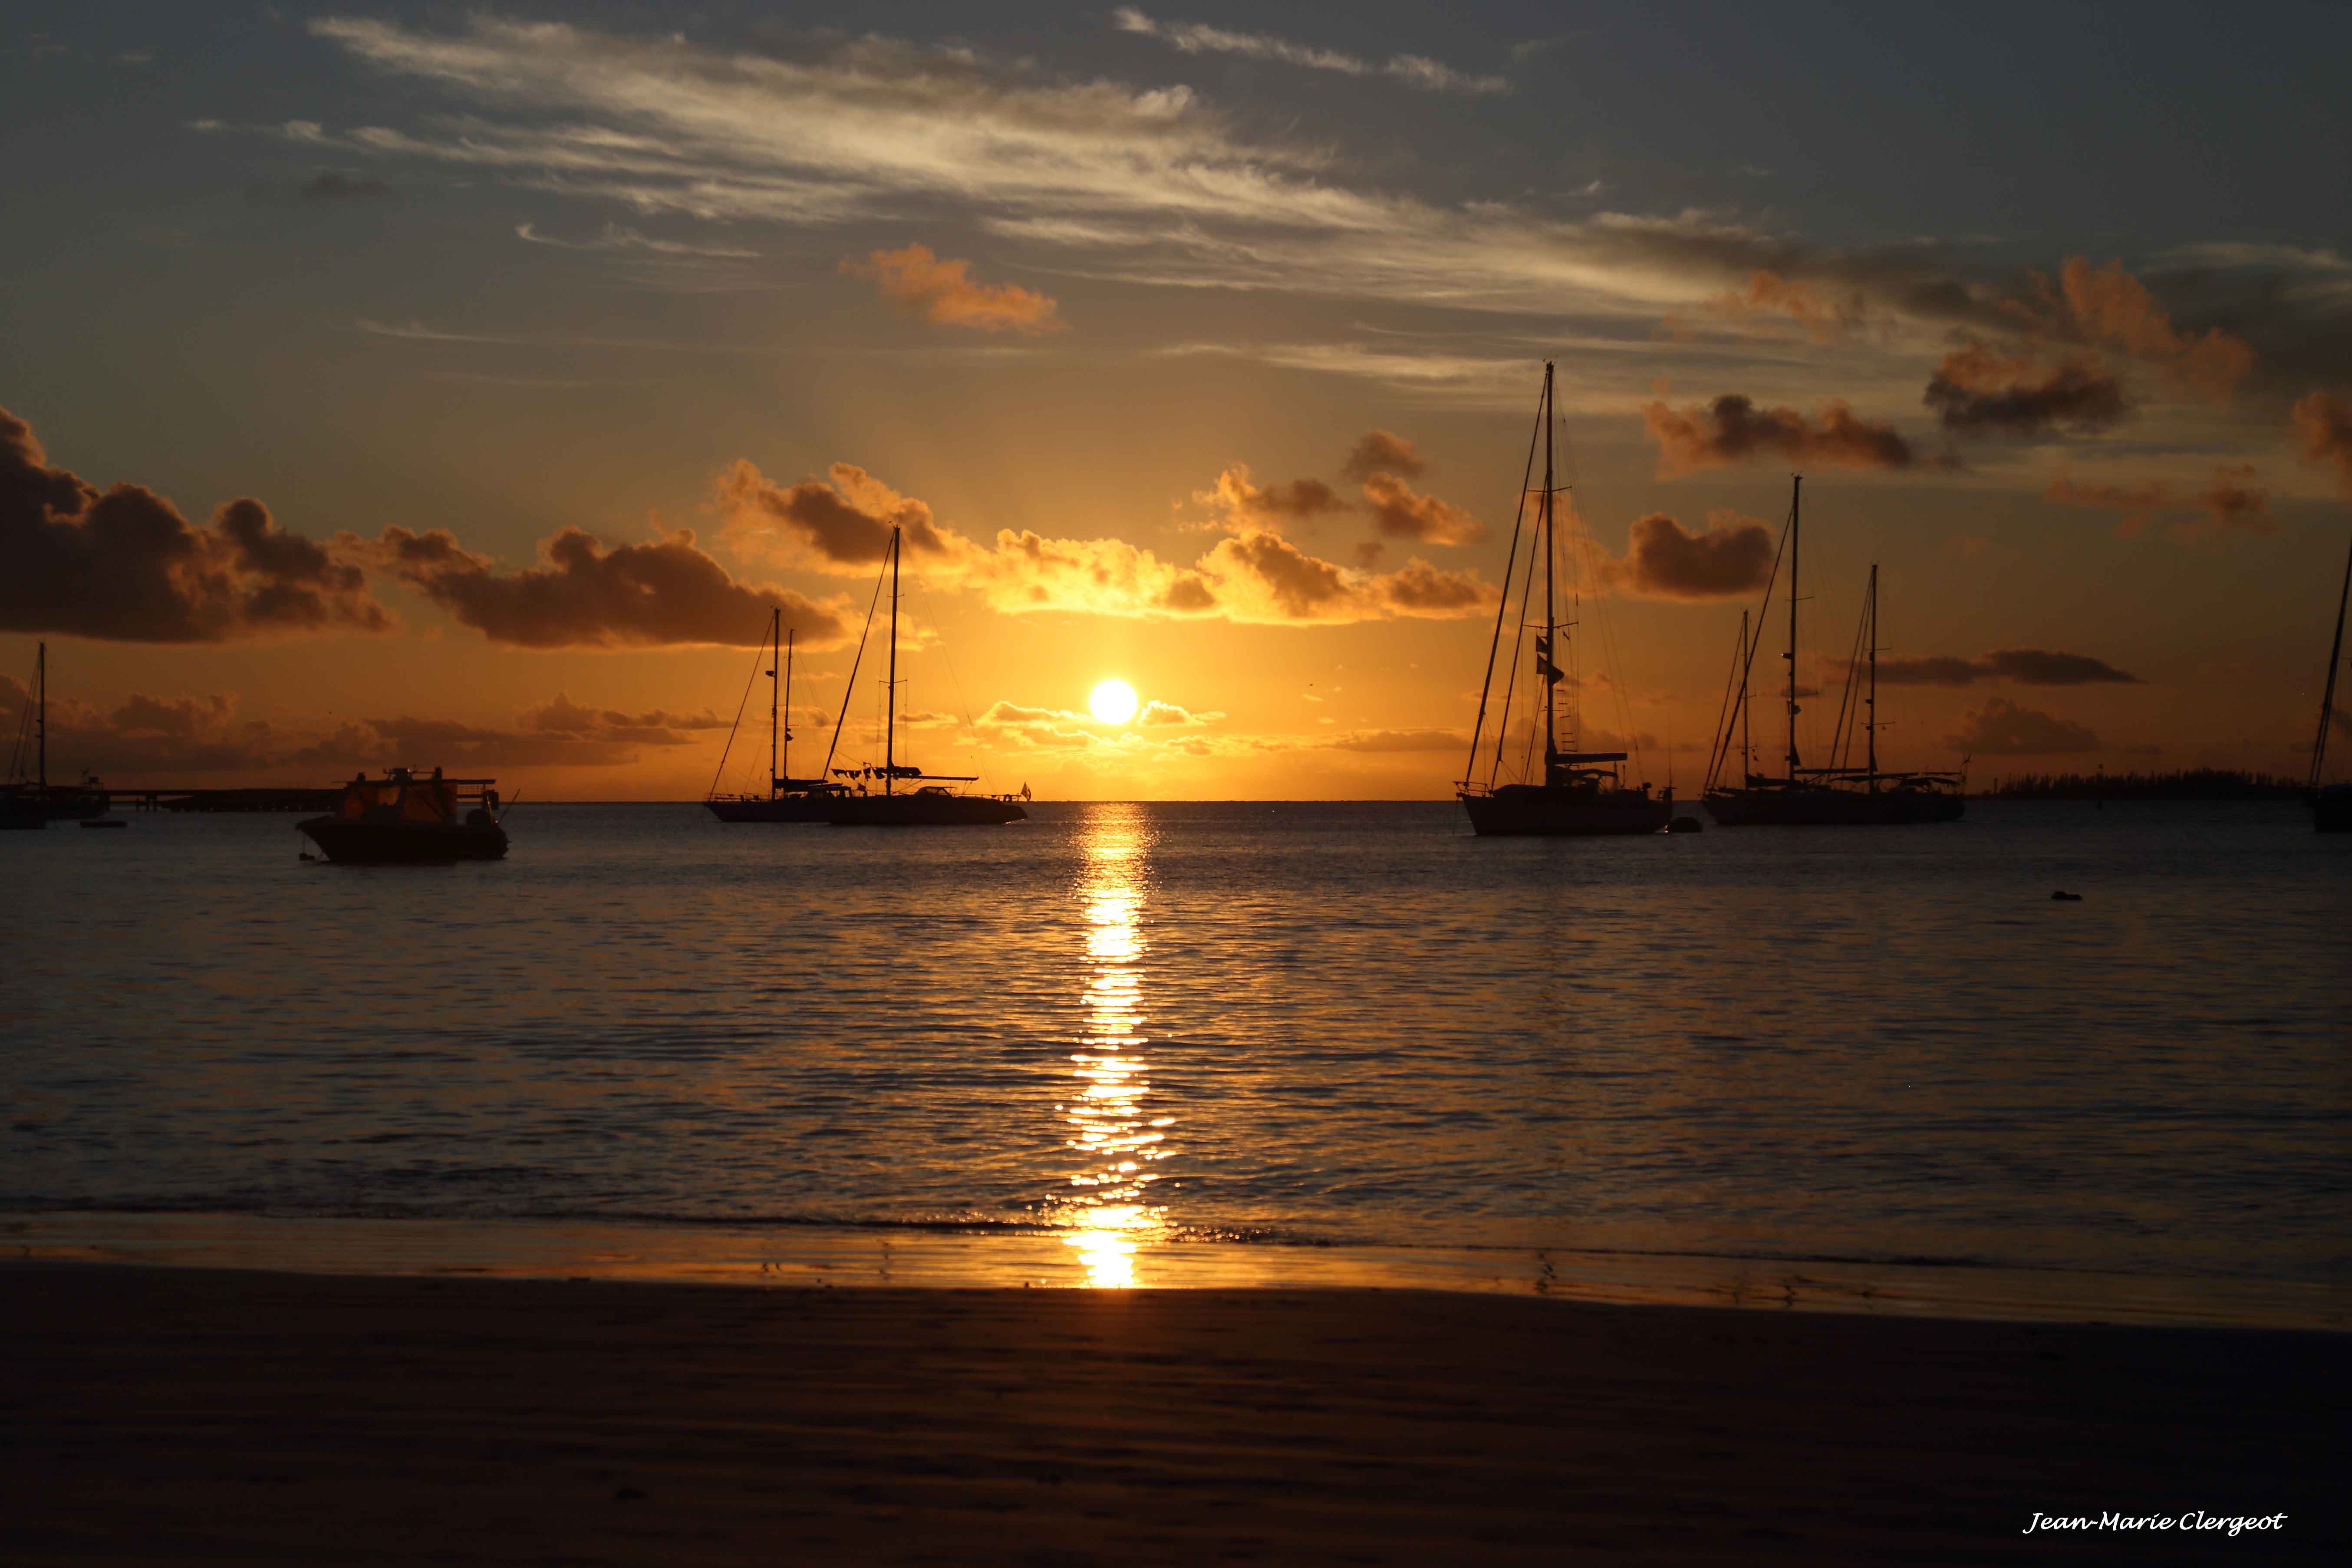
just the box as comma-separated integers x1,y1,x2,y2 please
1061,806,1174,1288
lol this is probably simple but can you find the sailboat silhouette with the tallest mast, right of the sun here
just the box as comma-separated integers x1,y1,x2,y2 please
1456,360,1675,837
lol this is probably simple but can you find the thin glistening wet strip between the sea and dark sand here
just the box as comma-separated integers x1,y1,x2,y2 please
0,1211,2352,1333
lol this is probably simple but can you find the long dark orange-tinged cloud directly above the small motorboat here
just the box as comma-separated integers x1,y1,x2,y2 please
353,527,849,649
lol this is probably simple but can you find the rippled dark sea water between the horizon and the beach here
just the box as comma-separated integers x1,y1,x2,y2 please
0,802,2352,1321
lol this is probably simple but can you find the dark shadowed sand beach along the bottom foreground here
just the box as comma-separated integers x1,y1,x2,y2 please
0,1262,2352,1563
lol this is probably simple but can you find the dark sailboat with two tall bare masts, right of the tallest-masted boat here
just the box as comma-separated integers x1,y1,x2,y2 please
1700,475,1966,827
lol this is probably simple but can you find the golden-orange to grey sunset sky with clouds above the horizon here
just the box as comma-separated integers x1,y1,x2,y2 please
0,5,2352,799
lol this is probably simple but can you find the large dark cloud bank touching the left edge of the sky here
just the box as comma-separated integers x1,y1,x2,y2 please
0,409,393,642
